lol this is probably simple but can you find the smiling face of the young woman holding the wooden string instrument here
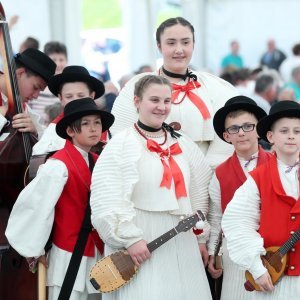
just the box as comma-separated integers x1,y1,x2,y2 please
134,83,171,128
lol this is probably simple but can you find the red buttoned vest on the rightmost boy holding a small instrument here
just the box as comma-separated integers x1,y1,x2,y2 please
250,155,300,276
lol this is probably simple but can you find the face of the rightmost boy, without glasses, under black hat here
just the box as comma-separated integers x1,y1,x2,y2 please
267,118,300,159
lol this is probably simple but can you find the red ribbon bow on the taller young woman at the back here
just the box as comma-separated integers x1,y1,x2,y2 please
171,81,211,120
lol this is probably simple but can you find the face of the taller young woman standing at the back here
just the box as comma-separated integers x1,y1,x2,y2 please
158,24,194,73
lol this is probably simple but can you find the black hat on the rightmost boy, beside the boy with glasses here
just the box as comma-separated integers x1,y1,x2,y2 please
256,100,300,141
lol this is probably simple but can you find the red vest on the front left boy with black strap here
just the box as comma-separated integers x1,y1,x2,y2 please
51,140,103,257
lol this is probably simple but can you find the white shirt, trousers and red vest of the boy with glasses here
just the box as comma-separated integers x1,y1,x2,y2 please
208,148,272,300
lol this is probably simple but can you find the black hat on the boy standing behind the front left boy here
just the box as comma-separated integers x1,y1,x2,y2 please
48,66,105,98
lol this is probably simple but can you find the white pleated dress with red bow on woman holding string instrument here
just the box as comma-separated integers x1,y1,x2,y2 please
91,126,211,300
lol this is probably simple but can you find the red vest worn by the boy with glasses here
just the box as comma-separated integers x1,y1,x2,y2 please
216,146,273,213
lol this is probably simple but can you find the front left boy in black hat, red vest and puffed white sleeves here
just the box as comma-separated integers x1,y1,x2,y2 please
6,98,114,300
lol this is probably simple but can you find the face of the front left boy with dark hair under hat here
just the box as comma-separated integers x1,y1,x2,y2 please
67,115,102,152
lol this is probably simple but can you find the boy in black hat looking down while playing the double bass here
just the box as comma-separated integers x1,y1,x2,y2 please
0,48,56,138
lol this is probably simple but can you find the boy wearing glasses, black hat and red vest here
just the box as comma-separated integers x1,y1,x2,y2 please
208,96,271,299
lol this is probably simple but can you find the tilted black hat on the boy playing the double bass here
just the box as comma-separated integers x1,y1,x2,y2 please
15,48,56,82
